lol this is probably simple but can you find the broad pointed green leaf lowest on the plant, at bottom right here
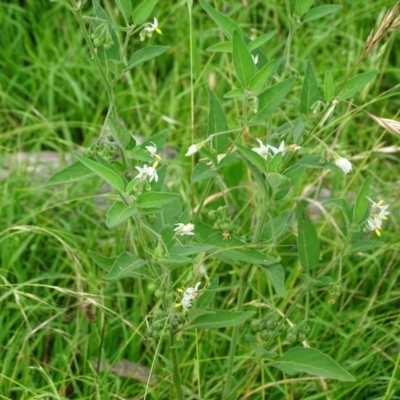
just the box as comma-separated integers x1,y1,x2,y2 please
269,347,356,382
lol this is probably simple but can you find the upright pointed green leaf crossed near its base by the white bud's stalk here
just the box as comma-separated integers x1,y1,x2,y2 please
207,88,229,154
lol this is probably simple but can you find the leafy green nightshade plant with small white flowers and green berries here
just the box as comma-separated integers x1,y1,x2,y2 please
47,0,399,399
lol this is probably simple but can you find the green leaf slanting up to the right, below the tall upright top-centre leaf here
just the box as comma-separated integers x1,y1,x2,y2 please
251,76,296,123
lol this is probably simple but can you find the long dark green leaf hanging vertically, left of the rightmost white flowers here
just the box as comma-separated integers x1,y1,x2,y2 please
296,203,319,271
